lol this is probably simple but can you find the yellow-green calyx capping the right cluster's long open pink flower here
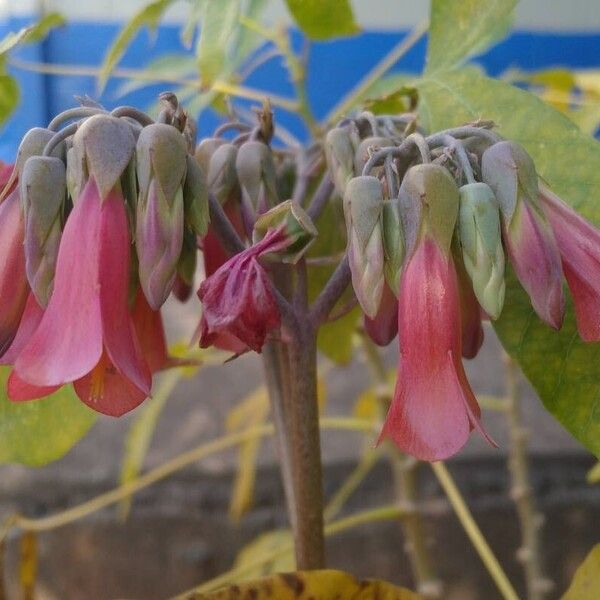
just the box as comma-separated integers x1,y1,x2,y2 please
399,163,458,257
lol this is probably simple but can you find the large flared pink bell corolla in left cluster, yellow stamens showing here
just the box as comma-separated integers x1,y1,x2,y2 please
8,177,151,416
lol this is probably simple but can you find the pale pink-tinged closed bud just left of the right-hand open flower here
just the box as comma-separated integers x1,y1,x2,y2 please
344,175,385,318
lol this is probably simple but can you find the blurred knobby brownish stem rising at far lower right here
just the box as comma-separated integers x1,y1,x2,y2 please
504,355,553,600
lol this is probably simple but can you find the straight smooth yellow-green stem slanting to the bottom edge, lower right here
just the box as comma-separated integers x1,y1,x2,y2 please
430,461,519,600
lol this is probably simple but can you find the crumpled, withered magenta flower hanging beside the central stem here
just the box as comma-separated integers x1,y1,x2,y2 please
198,229,289,352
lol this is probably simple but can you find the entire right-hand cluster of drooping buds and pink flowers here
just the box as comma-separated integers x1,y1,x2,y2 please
327,115,600,460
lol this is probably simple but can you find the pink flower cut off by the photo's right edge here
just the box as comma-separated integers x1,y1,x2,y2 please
540,186,600,342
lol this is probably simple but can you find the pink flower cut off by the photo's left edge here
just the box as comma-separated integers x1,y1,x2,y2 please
0,165,29,356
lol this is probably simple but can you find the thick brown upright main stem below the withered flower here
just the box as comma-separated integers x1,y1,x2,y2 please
289,319,325,570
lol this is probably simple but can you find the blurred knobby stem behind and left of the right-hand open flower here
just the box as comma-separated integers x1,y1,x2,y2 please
361,334,442,600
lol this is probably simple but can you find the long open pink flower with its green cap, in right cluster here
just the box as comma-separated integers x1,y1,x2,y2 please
380,164,487,461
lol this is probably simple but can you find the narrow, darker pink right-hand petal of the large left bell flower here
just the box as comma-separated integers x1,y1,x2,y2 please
98,190,152,396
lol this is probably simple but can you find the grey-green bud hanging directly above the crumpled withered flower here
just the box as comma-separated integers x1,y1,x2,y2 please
235,140,279,214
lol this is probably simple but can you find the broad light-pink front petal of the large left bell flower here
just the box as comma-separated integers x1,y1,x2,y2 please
15,179,102,386
